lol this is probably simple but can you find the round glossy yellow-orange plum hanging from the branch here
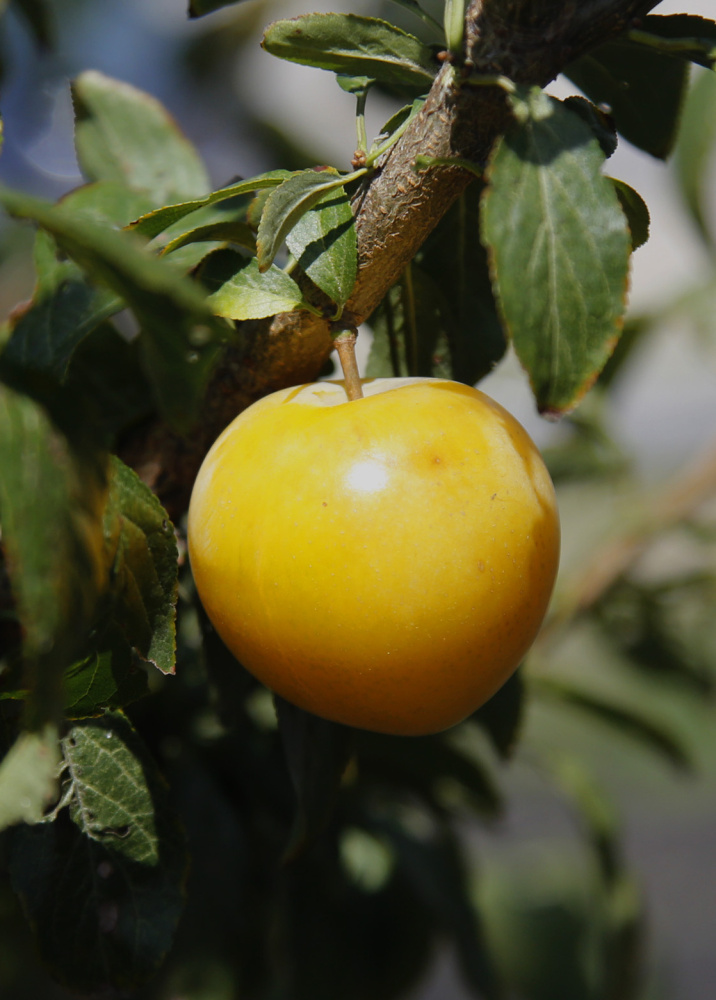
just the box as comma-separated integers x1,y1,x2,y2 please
189,378,559,735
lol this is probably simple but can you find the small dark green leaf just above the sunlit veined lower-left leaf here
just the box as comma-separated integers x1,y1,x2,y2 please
65,626,149,719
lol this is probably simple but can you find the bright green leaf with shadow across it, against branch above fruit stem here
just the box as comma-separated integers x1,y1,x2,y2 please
286,191,358,307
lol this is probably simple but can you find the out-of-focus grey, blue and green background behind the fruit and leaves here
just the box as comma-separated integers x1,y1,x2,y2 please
0,0,716,1000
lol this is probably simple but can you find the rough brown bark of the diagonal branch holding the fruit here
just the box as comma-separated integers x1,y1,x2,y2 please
123,0,658,518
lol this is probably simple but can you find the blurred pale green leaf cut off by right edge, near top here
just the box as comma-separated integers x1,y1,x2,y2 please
675,67,716,244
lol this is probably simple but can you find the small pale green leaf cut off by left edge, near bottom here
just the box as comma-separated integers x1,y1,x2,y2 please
0,725,60,830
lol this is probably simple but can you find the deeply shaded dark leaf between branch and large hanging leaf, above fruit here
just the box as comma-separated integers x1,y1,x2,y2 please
418,184,507,385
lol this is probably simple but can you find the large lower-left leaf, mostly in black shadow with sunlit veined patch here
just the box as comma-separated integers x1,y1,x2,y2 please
10,714,187,995
